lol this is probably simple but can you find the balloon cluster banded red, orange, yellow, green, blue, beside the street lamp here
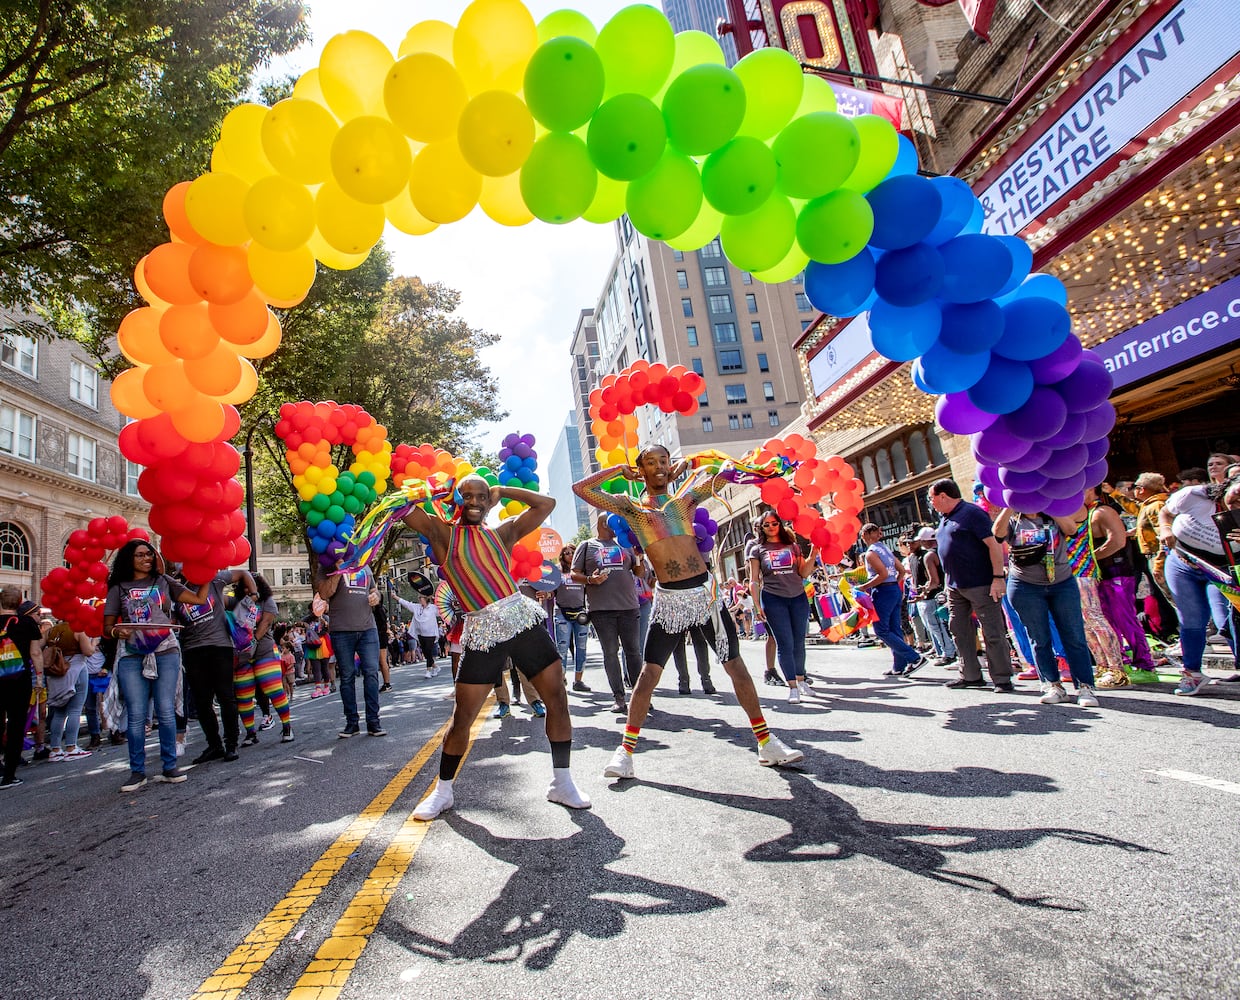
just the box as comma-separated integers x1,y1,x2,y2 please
275,400,392,568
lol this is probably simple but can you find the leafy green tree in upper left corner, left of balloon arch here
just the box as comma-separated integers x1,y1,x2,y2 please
0,0,309,361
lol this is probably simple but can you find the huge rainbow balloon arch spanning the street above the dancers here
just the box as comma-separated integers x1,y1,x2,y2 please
112,0,1115,579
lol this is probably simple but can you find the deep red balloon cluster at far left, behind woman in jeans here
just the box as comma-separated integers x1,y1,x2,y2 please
38,515,150,636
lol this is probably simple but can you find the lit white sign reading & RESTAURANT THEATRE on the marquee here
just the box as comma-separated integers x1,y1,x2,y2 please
978,0,1238,236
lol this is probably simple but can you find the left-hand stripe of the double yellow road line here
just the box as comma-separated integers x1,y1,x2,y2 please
191,713,451,1000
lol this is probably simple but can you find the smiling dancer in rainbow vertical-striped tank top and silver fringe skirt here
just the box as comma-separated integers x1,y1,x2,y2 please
404,475,590,820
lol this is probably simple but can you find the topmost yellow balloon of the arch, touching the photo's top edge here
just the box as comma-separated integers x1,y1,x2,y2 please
453,0,538,94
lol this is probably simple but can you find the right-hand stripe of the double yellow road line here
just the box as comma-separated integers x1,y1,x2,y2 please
288,699,490,1000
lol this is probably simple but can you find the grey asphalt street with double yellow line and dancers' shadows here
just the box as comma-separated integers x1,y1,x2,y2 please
0,643,1240,1000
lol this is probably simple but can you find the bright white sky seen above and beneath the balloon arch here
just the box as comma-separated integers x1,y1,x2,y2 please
272,0,644,461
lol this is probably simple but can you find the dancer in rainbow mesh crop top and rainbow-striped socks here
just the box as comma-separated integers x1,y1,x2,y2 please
573,444,805,778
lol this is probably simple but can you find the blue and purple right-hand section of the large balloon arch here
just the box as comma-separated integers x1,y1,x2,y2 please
805,168,1115,514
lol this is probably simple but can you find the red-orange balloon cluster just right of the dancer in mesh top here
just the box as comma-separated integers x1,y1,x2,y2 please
755,433,864,565
